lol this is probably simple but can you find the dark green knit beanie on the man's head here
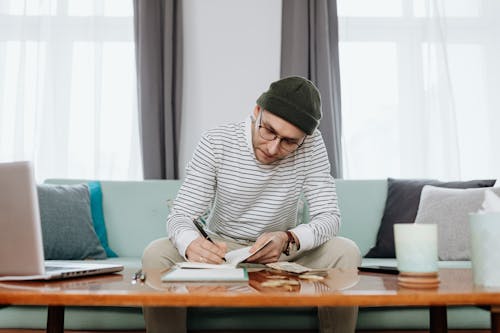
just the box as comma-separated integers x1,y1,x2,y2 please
257,76,321,135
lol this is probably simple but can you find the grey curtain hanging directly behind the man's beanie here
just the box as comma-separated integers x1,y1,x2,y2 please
281,0,342,178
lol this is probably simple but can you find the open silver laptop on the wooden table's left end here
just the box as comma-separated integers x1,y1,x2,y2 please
0,161,123,281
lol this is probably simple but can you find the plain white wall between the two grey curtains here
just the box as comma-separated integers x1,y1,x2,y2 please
179,0,281,177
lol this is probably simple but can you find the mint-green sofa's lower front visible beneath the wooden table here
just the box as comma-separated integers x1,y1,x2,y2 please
0,306,490,332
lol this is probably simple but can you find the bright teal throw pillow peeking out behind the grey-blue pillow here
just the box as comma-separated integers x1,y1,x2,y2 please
87,181,118,258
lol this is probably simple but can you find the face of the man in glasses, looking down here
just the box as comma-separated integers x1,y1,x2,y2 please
252,106,306,164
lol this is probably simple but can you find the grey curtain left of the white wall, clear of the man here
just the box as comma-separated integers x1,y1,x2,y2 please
134,0,182,179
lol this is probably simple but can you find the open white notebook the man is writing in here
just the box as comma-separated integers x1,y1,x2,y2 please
161,238,273,282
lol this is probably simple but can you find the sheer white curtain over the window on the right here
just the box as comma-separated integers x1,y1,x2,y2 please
338,0,500,179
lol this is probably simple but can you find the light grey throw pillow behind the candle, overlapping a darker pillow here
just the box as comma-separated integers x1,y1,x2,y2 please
415,185,500,260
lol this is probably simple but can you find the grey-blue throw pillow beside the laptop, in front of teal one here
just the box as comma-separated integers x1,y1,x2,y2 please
37,184,106,260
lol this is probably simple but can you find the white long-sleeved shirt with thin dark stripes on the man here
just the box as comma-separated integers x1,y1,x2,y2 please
167,117,340,256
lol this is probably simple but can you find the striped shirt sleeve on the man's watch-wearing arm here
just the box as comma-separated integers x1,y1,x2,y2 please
292,131,340,252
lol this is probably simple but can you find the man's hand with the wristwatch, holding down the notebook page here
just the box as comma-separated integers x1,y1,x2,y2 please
246,231,288,264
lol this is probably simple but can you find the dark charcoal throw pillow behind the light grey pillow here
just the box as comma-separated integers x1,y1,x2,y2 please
366,178,495,258
